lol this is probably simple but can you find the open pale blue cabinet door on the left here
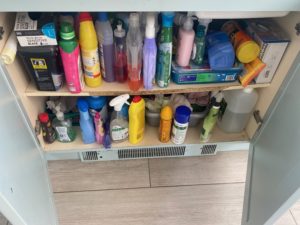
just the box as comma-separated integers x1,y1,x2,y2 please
0,62,58,225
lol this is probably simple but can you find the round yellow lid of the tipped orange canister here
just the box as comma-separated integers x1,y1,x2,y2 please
236,41,260,63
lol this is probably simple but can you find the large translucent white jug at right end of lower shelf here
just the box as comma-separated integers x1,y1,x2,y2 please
218,88,258,133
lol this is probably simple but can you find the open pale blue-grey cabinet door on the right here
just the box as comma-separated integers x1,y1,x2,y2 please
242,53,300,225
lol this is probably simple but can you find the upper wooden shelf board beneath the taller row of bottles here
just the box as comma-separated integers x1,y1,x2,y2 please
25,81,270,97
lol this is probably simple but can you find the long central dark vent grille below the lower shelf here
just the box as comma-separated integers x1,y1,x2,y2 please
118,146,185,159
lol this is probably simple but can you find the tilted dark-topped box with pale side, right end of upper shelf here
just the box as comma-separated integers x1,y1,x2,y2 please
245,19,290,83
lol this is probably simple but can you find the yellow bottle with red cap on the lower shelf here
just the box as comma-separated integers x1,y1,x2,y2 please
129,96,145,144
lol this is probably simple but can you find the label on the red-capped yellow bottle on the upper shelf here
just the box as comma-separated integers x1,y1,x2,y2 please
81,48,101,78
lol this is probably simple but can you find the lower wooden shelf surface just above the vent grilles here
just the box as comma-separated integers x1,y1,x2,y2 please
44,124,248,152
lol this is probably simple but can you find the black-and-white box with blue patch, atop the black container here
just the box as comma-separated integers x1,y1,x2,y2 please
14,12,57,47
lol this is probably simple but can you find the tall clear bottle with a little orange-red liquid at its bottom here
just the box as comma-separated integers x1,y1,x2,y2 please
126,13,143,91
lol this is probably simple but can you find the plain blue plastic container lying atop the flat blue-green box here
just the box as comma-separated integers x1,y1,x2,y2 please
206,32,235,70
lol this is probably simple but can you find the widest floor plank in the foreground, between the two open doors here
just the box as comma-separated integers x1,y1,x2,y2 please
55,184,244,225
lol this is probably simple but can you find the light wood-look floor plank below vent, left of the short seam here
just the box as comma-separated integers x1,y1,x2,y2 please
48,159,150,192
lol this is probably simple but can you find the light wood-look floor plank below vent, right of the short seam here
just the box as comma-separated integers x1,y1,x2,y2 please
149,151,248,187
